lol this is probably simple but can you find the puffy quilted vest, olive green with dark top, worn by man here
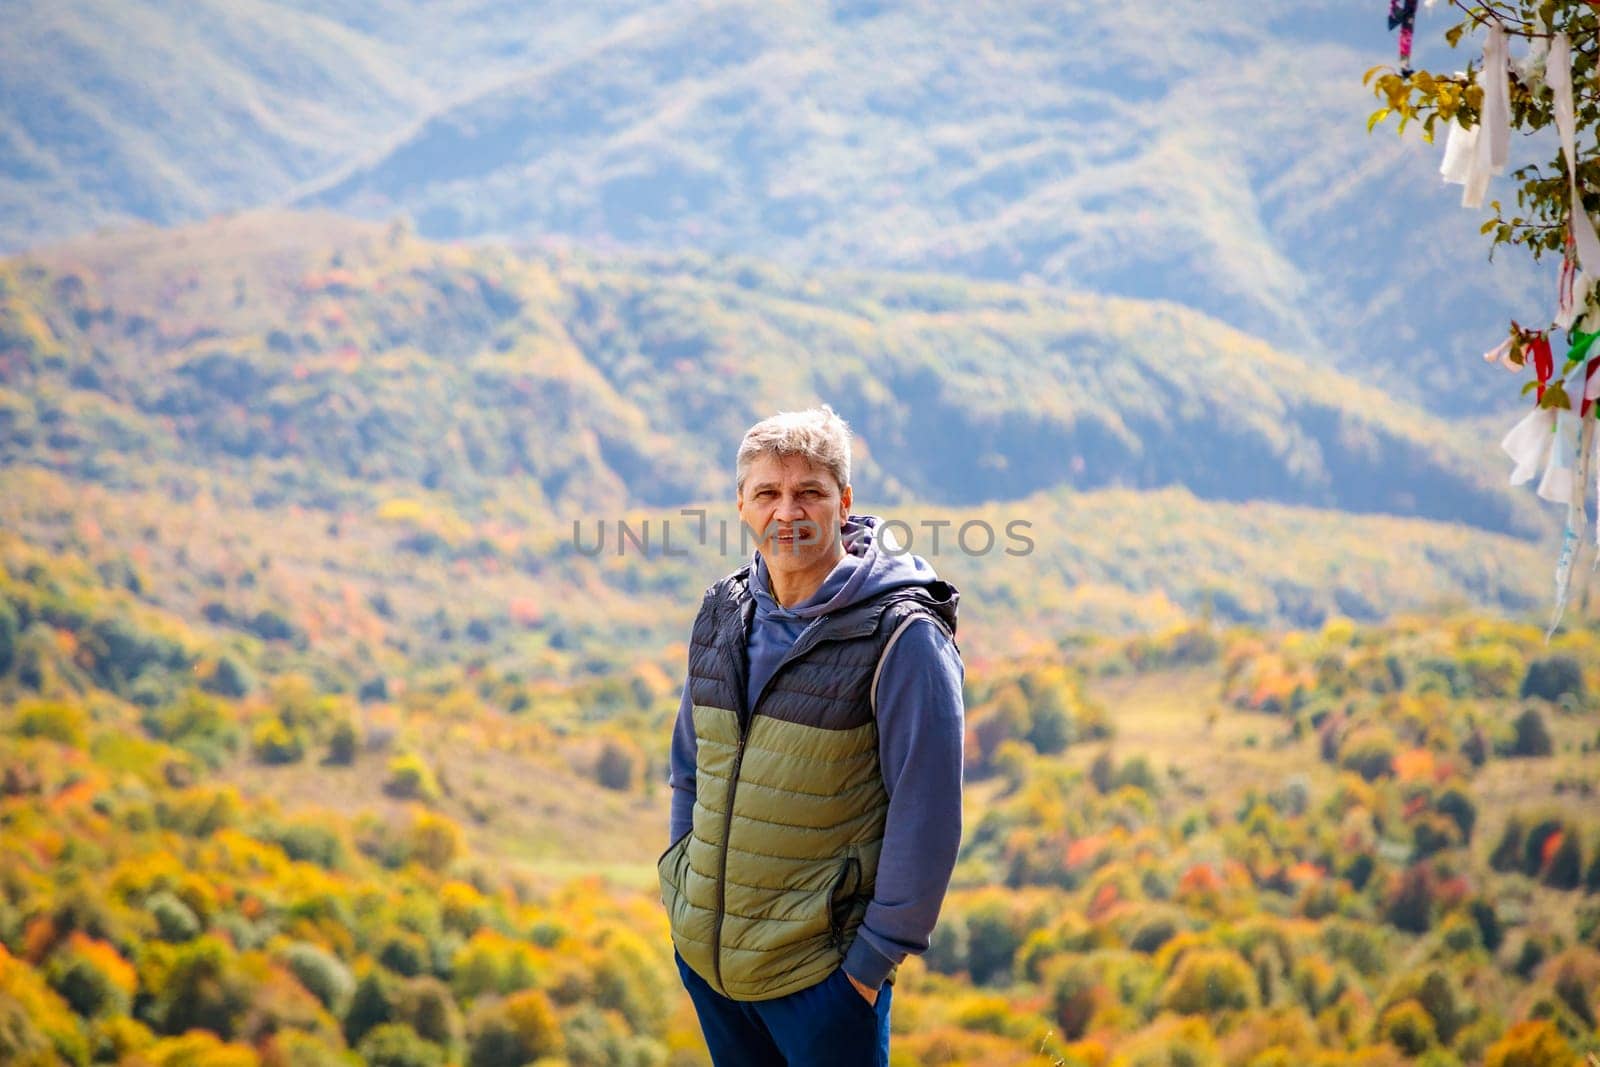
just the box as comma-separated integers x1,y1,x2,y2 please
656,565,958,1000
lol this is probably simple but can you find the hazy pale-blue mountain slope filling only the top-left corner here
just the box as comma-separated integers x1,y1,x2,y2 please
0,0,430,248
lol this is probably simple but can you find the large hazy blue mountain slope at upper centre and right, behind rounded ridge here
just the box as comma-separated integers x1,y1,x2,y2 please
294,0,1542,411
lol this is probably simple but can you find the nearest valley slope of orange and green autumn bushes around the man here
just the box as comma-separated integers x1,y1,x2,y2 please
0,528,1600,1067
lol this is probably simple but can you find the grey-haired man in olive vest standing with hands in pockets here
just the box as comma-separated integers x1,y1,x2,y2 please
656,405,963,1067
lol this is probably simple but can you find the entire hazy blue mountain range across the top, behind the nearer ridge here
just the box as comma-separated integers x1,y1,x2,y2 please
0,0,1549,414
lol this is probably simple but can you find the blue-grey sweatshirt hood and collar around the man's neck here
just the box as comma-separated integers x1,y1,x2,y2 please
746,515,955,707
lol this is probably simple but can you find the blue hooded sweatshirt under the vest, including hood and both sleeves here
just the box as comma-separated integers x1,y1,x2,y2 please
667,515,965,989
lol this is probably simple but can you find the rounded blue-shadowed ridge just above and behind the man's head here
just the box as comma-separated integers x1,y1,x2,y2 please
0,214,1538,531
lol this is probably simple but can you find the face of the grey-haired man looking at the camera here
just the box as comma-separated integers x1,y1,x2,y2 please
736,456,850,574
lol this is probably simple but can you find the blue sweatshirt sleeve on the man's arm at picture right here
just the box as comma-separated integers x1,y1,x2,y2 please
843,619,965,989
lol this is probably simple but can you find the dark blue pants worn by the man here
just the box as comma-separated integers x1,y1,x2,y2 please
672,950,894,1067
